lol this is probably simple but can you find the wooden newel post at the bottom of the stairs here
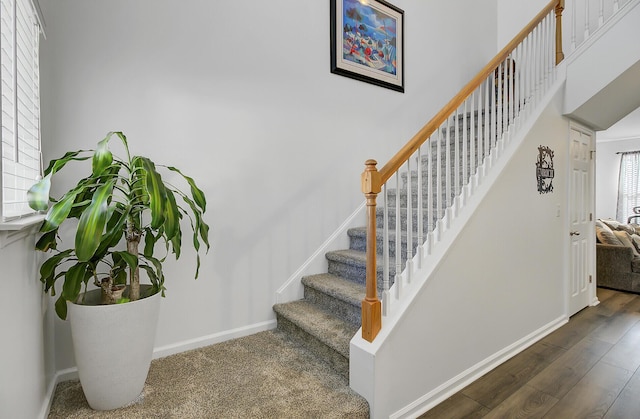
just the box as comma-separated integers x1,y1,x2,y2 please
362,160,382,342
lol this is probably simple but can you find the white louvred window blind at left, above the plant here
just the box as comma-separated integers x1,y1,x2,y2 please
0,0,41,222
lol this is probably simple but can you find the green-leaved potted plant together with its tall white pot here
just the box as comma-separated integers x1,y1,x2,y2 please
28,132,209,410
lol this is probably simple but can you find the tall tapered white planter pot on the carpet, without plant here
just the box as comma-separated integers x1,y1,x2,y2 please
68,286,161,410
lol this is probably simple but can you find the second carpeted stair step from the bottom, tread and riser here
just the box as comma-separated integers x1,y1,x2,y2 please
302,274,366,327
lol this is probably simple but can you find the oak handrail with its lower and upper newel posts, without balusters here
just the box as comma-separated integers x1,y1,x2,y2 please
362,0,564,342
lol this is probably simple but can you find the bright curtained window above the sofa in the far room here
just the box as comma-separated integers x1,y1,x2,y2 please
616,151,640,223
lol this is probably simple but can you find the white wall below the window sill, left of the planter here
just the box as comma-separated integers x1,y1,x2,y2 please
0,231,55,419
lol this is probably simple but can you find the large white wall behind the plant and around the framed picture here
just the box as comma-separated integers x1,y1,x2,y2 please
41,0,496,370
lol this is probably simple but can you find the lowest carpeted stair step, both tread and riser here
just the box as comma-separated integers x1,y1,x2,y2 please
273,300,360,378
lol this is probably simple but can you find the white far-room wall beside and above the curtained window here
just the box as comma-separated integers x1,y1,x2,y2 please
596,137,640,221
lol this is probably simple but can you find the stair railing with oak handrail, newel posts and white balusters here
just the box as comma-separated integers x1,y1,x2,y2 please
362,0,564,342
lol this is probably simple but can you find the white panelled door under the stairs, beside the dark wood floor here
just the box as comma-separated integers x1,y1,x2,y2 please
567,123,596,316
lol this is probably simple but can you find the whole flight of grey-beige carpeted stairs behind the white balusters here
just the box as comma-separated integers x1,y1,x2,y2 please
273,112,484,379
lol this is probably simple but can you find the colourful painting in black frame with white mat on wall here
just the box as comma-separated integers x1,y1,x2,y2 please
331,0,404,92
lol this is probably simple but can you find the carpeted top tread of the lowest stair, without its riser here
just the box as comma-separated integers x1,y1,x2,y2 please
273,300,360,359
